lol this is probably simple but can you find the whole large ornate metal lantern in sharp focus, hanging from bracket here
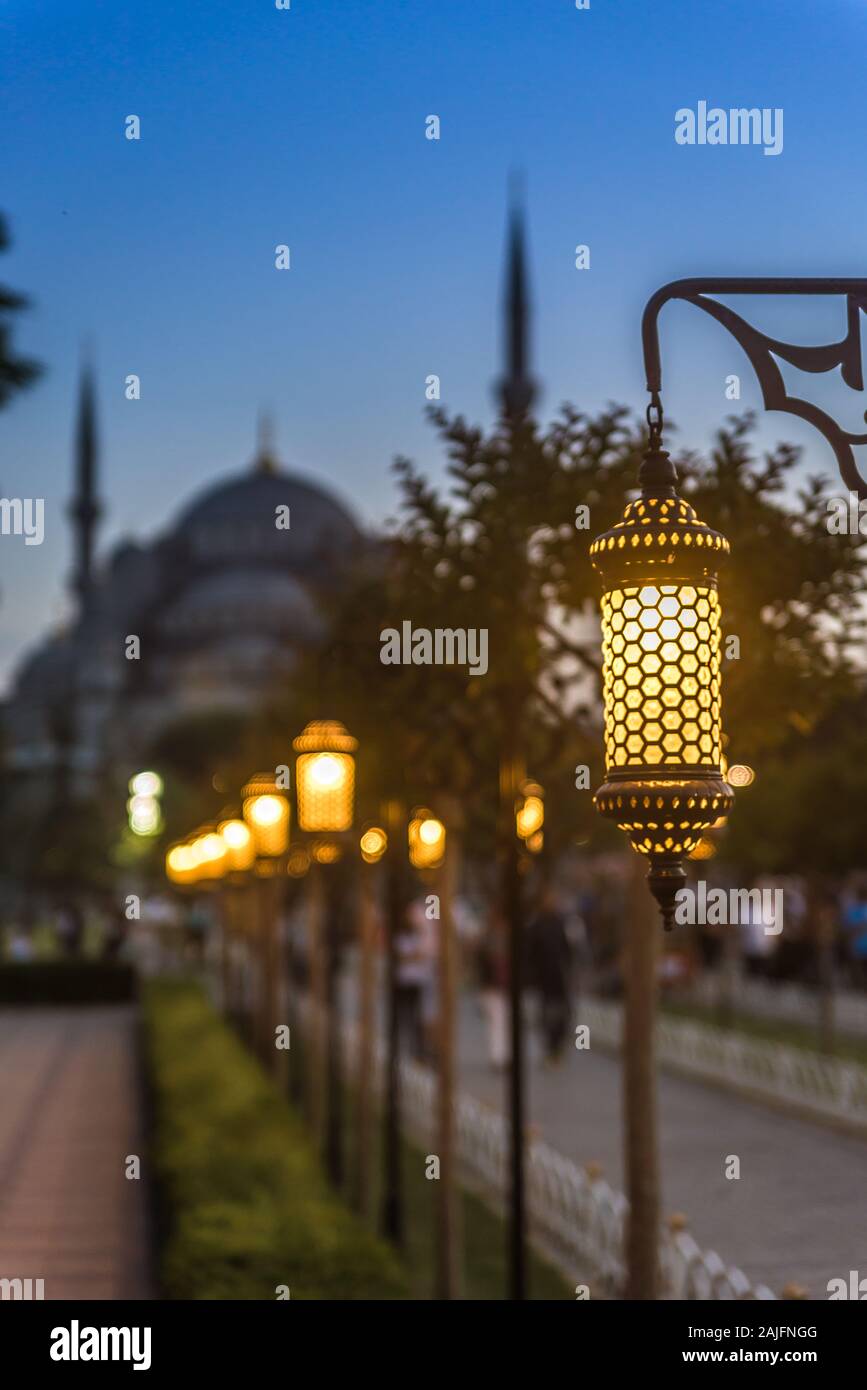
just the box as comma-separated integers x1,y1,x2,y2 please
591,433,734,930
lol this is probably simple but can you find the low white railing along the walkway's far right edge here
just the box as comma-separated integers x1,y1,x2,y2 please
581,999,867,1129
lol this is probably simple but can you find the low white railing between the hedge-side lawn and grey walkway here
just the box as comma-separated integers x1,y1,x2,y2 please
296,998,775,1300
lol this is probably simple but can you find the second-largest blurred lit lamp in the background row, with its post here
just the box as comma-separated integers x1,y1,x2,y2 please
240,771,289,1070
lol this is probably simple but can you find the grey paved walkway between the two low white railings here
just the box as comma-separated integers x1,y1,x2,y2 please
457,995,867,1298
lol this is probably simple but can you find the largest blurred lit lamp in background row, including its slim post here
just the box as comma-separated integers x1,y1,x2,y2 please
292,720,358,1186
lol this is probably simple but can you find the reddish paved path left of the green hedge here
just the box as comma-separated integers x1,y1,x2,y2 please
0,1006,153,1300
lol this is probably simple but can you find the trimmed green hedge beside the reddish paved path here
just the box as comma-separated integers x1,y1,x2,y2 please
145,981,407,1300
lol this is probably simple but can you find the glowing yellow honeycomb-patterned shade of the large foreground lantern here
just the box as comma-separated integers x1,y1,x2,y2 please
602,584,723,773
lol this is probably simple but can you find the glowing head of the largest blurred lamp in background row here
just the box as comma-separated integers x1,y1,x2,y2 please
293,720,358,834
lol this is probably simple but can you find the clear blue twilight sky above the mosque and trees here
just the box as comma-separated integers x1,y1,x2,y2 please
0,0,867,680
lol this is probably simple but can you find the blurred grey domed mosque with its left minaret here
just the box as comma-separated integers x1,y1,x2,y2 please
0,391,377,802
